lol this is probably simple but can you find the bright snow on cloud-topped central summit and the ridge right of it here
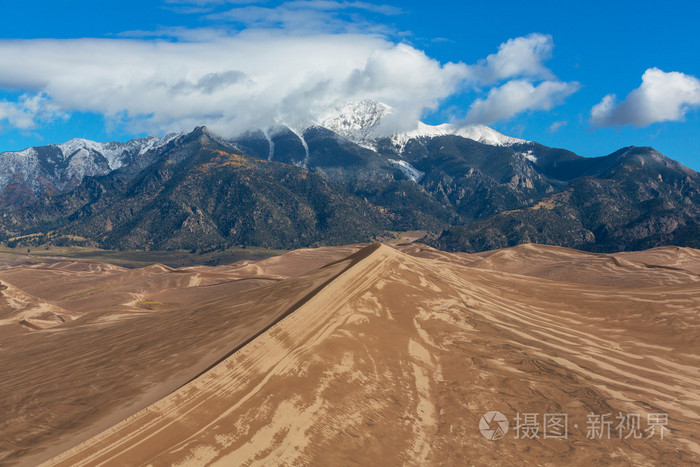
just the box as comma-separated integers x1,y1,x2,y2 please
319,100,528,150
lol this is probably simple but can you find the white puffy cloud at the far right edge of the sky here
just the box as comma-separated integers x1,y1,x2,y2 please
590,68,700,127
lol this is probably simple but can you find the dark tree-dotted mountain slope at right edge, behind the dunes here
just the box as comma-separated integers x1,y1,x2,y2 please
429,147,700,251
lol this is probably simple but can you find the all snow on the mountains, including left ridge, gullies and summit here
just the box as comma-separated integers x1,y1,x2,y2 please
0,100,524,207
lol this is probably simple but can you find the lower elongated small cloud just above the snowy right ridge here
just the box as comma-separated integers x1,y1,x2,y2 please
466,80,580,124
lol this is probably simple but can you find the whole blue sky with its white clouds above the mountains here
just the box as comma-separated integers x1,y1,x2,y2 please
0,0,700,170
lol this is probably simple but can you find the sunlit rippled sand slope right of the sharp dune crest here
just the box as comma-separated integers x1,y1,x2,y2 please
38,245,700,465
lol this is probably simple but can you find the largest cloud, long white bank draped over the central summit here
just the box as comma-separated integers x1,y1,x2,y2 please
0,32,466,135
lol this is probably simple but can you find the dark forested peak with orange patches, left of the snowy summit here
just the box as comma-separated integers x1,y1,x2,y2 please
4,128,387,249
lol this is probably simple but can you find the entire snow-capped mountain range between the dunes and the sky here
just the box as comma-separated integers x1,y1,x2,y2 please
0,101,700,252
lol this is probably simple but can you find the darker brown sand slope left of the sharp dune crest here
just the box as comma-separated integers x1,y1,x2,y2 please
0,248,366,465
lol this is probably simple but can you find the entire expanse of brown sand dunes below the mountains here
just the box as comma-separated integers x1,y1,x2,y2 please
0,244,700,465
